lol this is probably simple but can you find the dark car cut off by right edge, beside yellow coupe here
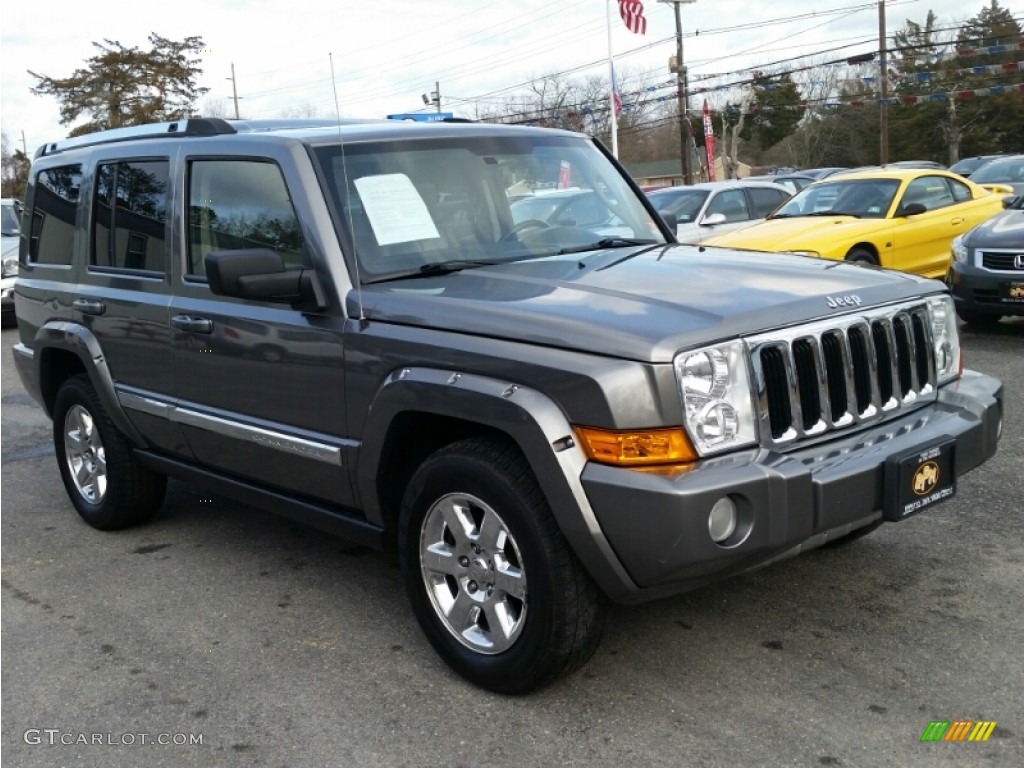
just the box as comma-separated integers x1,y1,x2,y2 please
946,195,1024,325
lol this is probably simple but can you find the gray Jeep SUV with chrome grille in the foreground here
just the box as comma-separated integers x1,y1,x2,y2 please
14,119,1002,692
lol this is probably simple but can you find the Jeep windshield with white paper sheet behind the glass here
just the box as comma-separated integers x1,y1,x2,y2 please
315,133,666,282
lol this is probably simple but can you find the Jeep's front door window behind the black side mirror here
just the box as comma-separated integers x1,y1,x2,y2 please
186,160,308,274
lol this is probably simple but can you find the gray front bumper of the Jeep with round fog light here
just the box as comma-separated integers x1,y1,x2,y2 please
582,371,1002,602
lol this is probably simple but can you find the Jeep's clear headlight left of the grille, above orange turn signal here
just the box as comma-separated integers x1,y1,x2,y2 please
673,341,757,456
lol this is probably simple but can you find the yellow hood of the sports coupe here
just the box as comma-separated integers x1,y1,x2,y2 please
705,216,892,251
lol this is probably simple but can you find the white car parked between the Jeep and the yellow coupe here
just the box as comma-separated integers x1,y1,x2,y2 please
647,180,791,243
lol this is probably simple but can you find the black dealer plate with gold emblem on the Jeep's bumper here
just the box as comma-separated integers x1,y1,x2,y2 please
883,438,956,522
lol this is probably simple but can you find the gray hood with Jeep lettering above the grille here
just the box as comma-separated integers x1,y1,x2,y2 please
348,245,942,362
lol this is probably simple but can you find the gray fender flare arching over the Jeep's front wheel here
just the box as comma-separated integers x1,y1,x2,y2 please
353,368,637,598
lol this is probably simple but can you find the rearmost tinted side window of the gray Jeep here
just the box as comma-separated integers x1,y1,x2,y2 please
29,164,82,264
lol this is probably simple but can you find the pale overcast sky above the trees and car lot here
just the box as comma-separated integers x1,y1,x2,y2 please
0,0,999,156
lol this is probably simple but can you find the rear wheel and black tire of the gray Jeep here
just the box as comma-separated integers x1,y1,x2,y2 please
53,375,167,530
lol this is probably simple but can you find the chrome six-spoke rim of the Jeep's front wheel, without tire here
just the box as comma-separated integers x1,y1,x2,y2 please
420,494,526,654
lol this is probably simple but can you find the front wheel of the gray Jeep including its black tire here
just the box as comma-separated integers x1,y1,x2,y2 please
399,437,607,693
